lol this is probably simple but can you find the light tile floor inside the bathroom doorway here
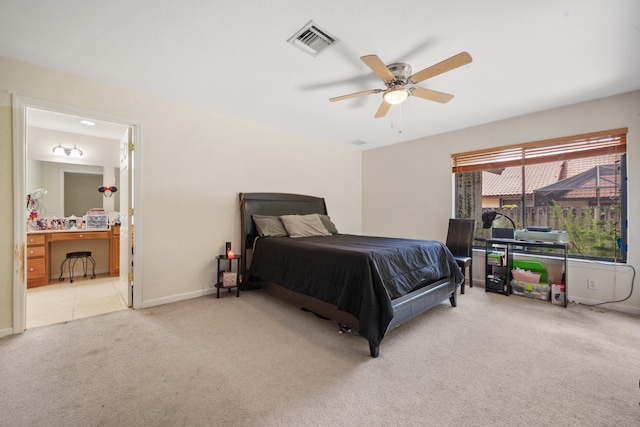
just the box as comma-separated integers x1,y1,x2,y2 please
27,275,127,329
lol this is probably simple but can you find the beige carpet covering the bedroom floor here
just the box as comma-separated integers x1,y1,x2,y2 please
0,287,640,427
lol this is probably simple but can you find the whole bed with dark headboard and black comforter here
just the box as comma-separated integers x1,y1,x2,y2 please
240,193,464,357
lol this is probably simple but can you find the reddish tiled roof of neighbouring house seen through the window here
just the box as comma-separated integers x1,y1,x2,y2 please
482,155,618,198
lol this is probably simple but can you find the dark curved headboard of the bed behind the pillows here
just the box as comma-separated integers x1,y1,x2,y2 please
240,193,327,280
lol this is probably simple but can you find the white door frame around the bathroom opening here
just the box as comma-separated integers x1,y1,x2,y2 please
11,94,142,334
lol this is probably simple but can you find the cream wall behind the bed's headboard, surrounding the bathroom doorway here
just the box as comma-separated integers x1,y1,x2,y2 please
0,57,362,335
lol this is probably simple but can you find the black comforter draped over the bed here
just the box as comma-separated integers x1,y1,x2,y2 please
251,234,464,352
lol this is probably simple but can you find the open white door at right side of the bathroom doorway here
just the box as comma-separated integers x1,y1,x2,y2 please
118,128,133,307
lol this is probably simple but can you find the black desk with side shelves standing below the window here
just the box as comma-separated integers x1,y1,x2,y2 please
485,239,569,308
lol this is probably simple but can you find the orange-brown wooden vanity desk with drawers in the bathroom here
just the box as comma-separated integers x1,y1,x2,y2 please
27,226,120,288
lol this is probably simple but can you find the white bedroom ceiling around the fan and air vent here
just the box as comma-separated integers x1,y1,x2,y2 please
0,0,640,149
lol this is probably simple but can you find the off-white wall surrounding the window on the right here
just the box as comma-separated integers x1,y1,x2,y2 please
362,92,640,314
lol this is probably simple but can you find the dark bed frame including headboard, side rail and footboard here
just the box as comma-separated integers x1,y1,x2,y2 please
240,193,458,357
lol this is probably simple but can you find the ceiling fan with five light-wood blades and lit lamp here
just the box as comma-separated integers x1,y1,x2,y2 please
329,52,472,118
